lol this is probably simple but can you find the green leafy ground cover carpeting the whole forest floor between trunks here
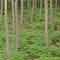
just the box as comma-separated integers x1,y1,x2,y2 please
0,9,60,60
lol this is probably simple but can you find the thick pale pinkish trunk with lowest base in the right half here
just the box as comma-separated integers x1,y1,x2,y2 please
44,0,49,48
